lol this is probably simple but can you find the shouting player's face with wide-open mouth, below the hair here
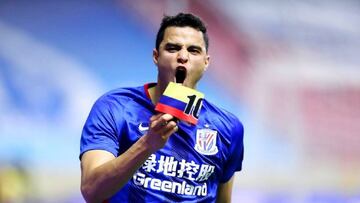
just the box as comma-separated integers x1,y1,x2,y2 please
153,26,209,89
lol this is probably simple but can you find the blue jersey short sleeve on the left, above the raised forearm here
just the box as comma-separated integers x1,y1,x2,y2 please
80,96,121,159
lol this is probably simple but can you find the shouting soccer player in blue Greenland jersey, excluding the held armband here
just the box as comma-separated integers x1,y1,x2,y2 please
80,13,243,203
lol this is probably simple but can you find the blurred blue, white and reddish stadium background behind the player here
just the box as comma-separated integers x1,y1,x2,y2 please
0,0,360,203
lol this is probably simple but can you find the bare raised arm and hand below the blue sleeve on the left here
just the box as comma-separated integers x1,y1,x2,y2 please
81,114,177,202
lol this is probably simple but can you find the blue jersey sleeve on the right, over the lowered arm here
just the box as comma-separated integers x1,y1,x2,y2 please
220,119,244,183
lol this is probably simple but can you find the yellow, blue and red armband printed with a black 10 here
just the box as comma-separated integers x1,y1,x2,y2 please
155,82,204,125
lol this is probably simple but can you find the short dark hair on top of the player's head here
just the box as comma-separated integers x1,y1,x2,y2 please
155,13,209,51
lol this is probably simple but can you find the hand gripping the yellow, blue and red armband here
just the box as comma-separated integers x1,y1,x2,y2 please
144,114,178,152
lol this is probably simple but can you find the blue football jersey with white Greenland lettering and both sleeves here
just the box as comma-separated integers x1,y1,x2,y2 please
80,84,244,203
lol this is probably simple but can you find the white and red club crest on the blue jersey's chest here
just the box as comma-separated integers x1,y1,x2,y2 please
195,128,218,155
